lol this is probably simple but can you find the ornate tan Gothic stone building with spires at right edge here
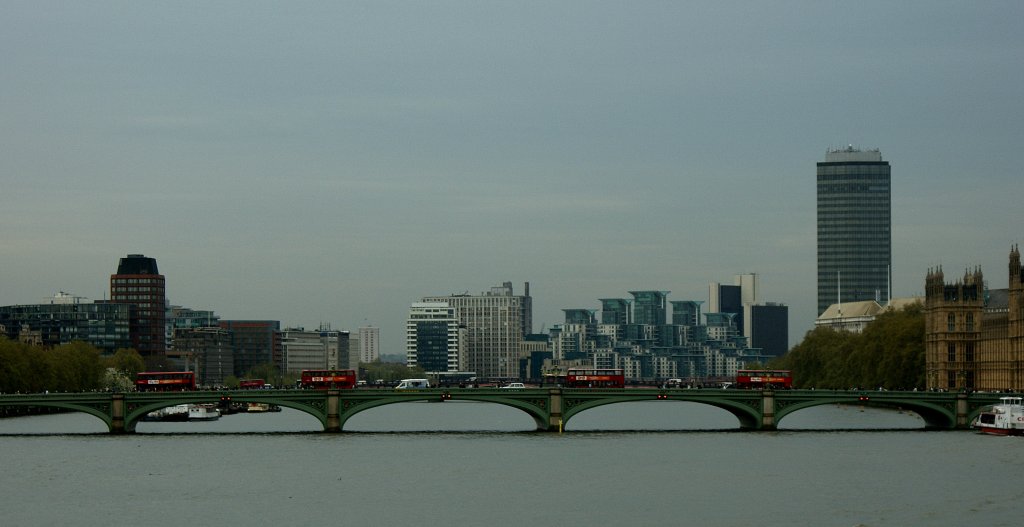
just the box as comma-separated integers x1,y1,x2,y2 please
925,247,1024,391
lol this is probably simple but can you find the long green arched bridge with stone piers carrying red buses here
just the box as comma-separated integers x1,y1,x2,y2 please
0,388,1005,434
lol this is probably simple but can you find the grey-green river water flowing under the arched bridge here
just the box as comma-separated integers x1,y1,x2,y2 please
0,401,1024,527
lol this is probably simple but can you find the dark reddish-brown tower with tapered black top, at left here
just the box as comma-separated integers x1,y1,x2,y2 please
111,255,167,357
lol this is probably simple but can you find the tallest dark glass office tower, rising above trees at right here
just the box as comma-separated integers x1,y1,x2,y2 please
818,146,892,315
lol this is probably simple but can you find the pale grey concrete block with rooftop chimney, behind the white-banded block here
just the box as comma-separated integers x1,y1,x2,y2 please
422,281,534,379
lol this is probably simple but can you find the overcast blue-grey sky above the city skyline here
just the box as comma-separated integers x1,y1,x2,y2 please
0,0,1024,354
